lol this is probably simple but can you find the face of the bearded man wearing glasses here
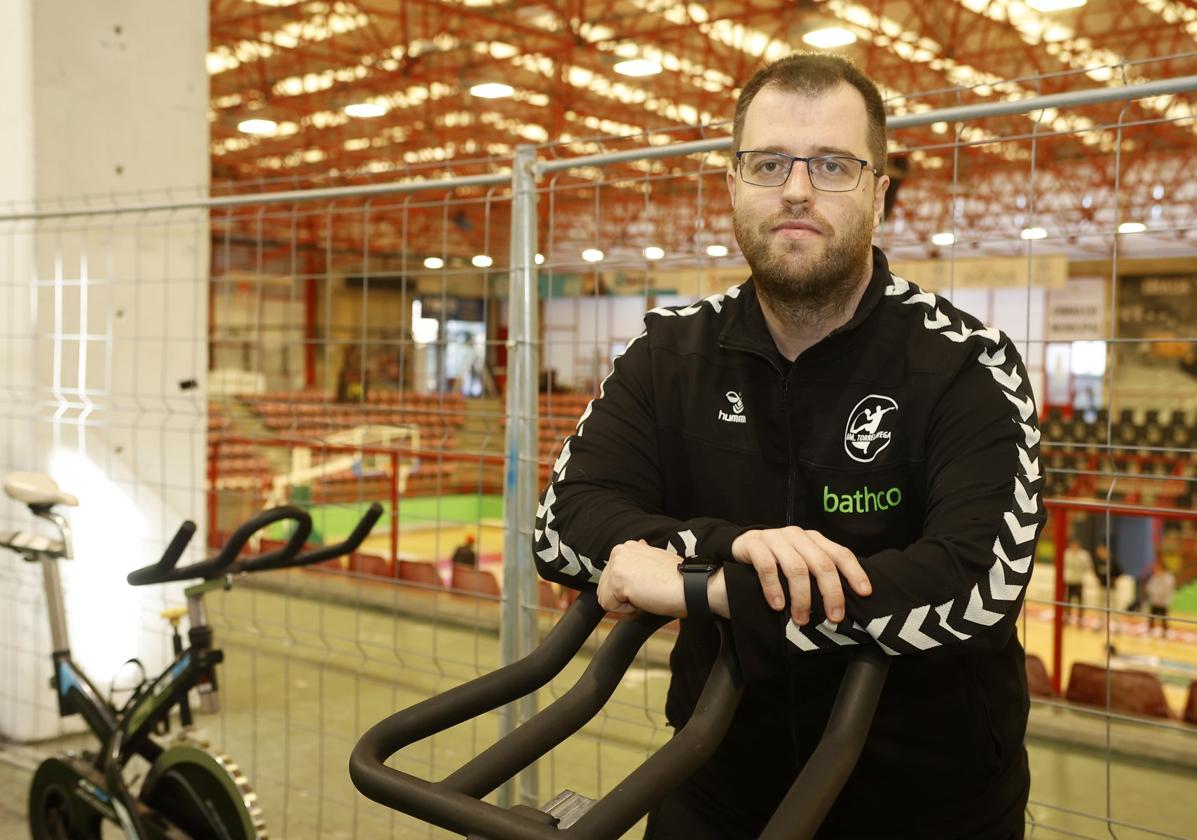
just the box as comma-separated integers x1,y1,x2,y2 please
728,83,889,314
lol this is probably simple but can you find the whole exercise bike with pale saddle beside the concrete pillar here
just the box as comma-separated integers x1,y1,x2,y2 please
0,473,382,840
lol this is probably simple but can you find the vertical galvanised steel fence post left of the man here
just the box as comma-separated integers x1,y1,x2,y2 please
499,146,540,808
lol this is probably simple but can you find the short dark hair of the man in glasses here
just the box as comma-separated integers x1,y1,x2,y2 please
731,53,888,174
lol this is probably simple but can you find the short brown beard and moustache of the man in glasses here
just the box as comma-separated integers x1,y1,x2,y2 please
731,202,873,324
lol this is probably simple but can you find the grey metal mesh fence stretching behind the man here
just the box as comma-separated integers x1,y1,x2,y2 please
0,61,1197,836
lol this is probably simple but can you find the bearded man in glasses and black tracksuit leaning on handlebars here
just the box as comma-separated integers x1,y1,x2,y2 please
535,55,1044,840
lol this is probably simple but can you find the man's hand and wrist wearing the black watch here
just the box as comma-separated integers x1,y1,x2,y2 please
599,540,728,619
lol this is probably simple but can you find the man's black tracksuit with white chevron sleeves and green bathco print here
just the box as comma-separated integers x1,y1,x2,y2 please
535,249,1045,838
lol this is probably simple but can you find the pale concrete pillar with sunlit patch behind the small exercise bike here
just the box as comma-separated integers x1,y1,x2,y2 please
0,0,209,741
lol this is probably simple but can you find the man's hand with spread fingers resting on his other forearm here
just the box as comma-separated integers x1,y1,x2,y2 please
731,525,873,625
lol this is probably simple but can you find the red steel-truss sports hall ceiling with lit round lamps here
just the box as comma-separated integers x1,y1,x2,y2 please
208,0,1197,263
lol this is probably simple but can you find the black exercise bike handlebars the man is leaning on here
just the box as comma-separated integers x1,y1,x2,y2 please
350,590,889,840
